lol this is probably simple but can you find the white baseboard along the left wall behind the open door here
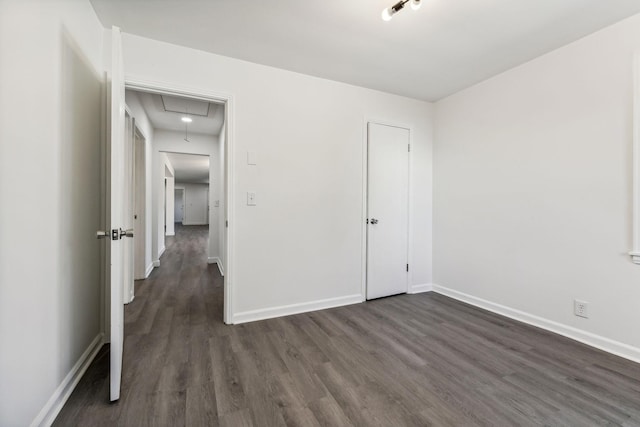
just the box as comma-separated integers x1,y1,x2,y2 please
31,333,103,427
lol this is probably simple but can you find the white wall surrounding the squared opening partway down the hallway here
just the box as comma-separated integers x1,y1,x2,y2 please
152,129,220,265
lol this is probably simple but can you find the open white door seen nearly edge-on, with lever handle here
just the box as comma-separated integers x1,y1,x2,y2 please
109,27,127,401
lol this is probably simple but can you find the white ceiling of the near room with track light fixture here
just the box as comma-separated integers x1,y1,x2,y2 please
91,0,640,101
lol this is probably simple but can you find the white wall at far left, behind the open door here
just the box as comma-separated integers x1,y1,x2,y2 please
0,0,104,427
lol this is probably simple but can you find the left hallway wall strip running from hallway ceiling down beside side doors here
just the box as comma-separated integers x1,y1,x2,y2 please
125,90,153,271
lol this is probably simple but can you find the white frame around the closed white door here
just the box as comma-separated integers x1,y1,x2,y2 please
360,117,415,302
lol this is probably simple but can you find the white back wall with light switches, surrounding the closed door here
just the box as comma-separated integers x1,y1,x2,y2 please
119,34,432,319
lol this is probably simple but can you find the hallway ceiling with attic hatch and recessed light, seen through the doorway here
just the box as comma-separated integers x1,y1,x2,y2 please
127,90,224,136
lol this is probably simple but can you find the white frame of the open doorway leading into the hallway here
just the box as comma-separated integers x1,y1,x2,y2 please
124,77,236,324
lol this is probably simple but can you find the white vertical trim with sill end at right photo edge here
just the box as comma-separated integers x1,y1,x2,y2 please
629,51,640,264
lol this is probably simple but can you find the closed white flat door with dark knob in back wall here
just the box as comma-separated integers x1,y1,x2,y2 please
367,123,409,299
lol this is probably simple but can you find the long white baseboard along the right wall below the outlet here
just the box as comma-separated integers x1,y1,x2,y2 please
433,285,640,363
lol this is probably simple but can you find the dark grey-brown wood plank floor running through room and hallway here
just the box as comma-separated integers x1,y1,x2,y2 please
55,227,640,426
